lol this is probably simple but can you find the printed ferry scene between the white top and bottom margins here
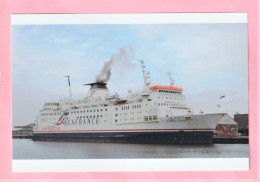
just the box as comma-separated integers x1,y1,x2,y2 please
11,13,249,160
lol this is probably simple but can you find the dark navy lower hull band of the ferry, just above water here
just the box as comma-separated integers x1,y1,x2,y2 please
32,131,214,144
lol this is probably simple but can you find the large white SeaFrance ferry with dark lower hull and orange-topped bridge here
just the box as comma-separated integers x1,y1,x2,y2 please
32,60,224,144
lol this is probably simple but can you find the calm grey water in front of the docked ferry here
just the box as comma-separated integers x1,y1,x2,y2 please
13,139,248,159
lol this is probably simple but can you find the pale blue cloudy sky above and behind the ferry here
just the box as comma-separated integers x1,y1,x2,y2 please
12,23,248,125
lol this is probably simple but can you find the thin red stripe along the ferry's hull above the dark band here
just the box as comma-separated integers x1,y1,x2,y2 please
34,128,215,133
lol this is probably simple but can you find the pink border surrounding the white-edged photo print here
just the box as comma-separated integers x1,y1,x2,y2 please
0,0,260,181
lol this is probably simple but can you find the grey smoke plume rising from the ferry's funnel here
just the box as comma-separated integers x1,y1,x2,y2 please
96,46,134,83
